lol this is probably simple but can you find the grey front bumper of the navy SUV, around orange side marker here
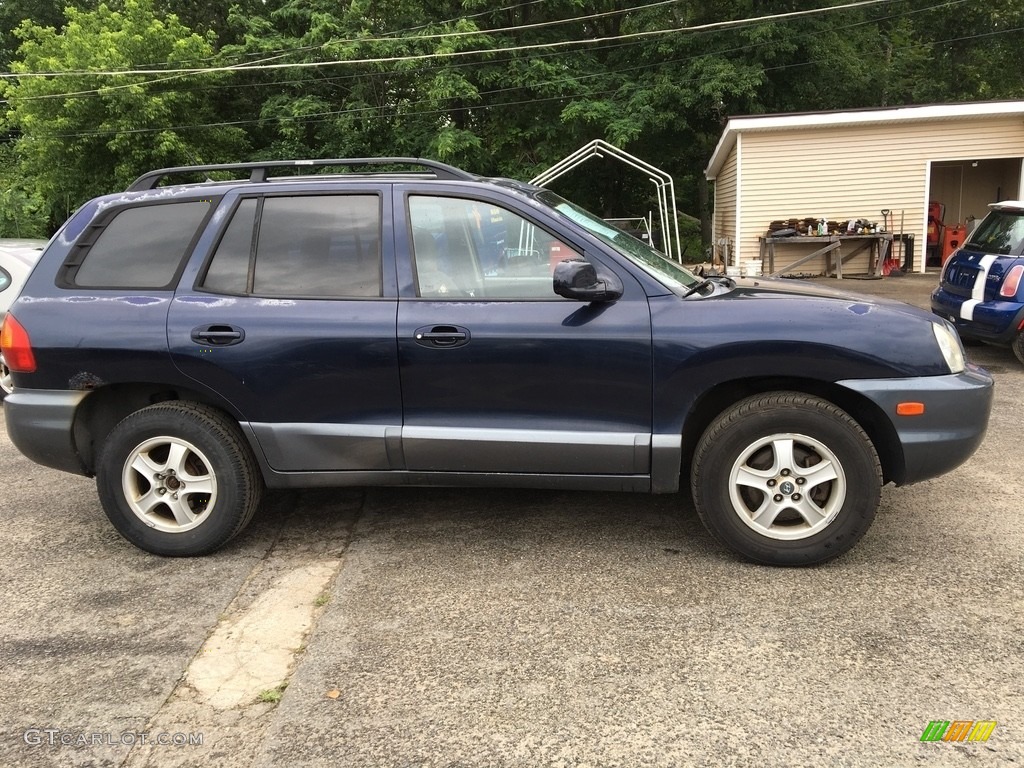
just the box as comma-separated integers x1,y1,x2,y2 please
839,366,993,485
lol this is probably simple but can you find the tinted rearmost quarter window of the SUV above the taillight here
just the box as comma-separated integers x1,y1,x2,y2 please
74,202,210,288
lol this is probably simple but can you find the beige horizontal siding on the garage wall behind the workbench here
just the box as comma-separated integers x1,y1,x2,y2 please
737,117,1024,271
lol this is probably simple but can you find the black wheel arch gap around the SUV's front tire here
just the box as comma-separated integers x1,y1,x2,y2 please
681,377,906,484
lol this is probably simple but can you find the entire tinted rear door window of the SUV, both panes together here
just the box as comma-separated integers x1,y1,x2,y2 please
201,195,382,298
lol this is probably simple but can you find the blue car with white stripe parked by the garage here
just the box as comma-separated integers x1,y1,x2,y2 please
932,200,1024,364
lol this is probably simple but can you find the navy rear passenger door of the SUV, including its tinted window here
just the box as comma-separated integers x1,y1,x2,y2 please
168,189,401,471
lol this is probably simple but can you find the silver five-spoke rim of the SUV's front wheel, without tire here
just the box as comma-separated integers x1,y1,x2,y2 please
729,433,847,541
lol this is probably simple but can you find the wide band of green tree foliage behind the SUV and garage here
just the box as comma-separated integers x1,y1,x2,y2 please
0,0,1024,237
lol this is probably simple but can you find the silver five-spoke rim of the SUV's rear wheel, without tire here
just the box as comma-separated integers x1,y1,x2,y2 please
121,436,217,534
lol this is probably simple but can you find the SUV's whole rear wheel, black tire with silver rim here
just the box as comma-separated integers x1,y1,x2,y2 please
96,400,263,557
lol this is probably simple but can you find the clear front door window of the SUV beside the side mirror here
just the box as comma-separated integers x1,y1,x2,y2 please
409,196,582,300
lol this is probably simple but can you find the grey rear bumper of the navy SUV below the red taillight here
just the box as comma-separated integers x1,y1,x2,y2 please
3,389,89,475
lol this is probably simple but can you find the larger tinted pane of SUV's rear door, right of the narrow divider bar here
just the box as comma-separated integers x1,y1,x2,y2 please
252,195,381,297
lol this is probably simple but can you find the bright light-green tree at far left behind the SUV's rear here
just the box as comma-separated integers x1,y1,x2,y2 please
4,0,245,226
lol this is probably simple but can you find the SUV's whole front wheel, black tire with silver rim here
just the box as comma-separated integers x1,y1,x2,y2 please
690,392,882,565
